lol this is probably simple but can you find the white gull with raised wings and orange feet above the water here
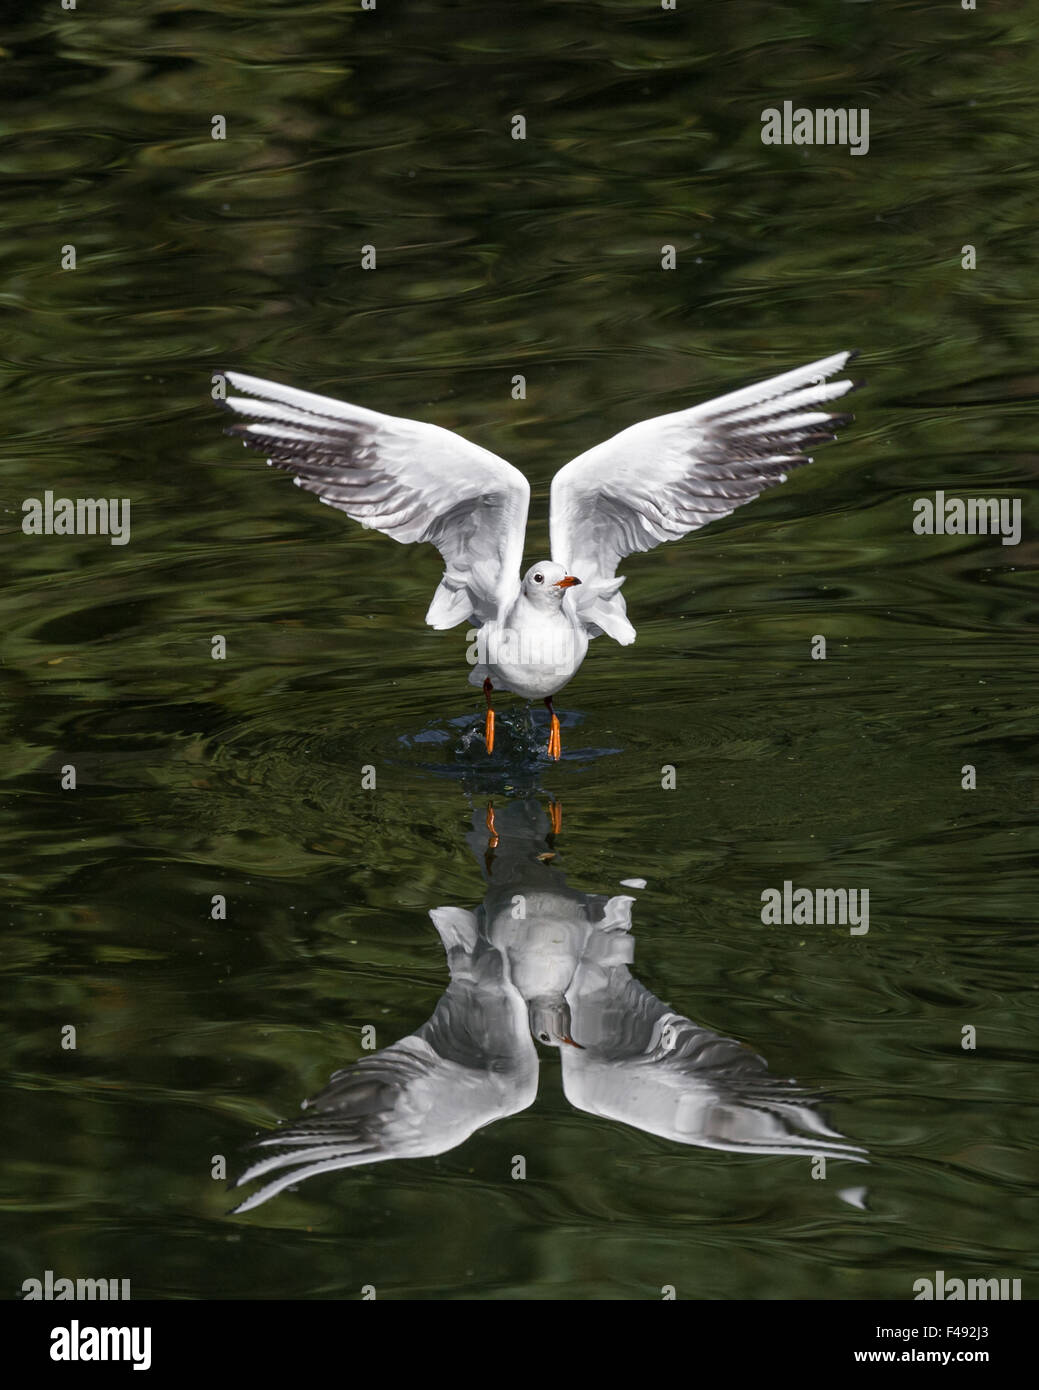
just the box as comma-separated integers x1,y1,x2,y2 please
220,352,860,759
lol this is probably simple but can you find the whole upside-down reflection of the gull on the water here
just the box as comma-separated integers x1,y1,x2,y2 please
235,802,862,1212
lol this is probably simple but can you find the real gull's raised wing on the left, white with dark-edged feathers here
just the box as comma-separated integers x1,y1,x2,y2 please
224,371,530,628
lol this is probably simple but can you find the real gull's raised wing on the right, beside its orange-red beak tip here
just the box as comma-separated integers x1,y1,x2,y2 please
551,352,857,645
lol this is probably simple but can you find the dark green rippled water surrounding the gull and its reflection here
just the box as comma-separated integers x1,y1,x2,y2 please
0,0,1039,1298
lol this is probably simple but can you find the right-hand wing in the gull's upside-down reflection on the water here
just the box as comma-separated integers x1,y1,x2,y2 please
562,942,864,1158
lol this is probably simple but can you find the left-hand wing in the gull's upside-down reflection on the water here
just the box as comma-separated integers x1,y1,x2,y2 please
235,908,538,1212
